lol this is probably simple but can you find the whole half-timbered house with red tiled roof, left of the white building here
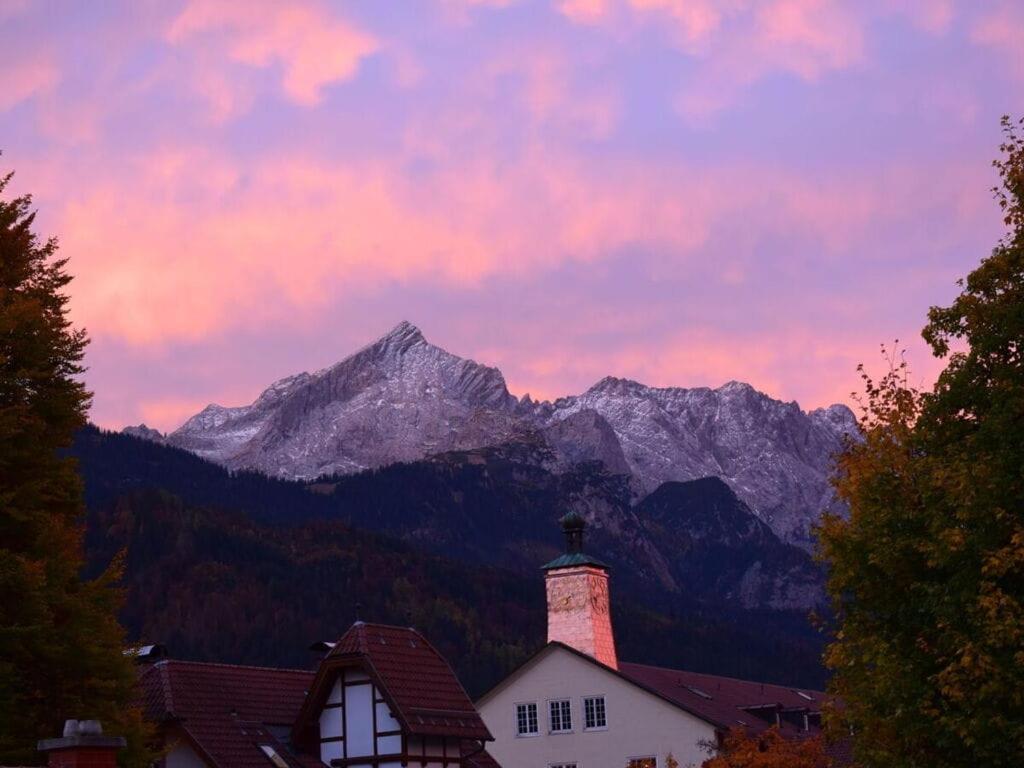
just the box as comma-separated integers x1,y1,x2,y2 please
139,622,498,768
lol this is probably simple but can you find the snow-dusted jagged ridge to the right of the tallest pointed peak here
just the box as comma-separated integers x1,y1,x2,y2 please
537,378,856,542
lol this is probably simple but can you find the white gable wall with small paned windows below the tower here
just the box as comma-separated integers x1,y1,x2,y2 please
477,646,715,768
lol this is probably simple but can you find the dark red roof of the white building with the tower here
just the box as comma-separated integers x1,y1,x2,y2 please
477,641,830,737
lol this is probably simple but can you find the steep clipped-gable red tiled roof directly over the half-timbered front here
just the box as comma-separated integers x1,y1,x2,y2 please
296,622,493,740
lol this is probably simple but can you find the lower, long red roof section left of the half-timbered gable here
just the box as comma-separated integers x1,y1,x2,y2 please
139,660,323,768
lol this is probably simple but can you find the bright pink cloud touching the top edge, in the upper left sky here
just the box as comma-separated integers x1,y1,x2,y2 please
168,0,379,105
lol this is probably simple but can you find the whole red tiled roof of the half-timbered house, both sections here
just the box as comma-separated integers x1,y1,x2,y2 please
139,623,497,768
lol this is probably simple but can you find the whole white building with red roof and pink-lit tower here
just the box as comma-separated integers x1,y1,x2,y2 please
476,514,825,768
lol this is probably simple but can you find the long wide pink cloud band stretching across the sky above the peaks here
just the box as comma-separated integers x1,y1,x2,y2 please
48,134,984,356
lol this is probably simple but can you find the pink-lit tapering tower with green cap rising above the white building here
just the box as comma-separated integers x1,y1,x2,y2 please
544,512,618,670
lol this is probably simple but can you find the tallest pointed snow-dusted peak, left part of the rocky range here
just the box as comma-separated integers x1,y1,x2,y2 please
167,323,518,478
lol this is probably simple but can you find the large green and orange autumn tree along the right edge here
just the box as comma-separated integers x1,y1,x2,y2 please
820,119,1024,768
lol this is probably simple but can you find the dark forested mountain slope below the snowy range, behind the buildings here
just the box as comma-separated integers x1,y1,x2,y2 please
74,428,823,691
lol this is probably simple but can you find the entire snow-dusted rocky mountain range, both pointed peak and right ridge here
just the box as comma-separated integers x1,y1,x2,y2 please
140,323,855,547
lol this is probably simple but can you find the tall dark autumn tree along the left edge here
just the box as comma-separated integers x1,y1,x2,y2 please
0,166,150,765
